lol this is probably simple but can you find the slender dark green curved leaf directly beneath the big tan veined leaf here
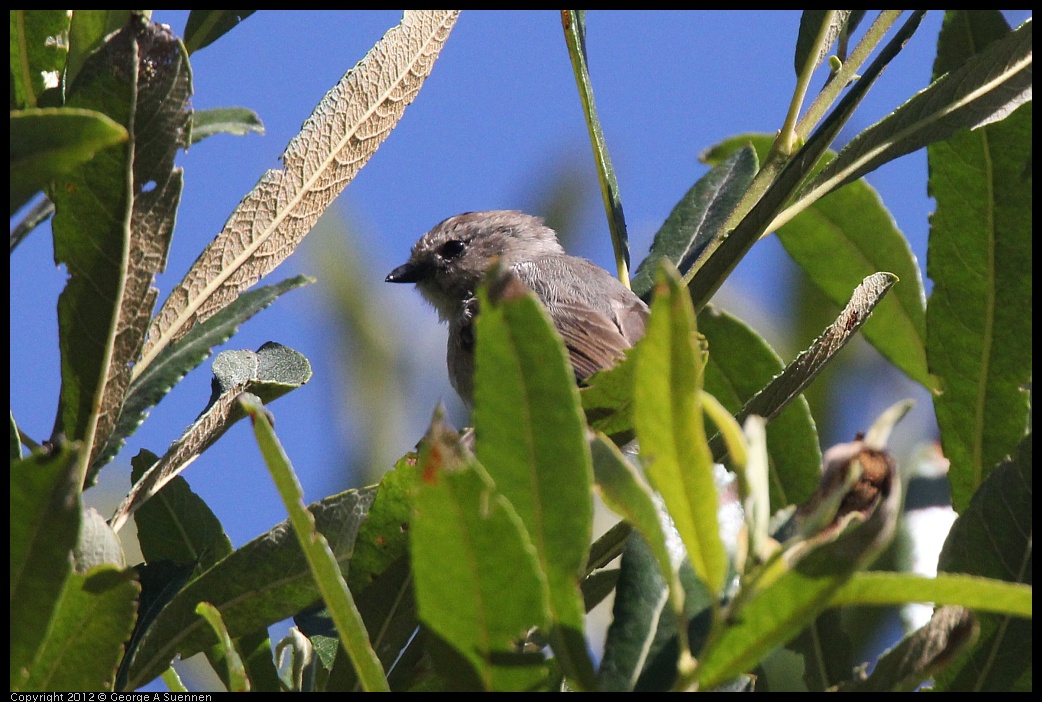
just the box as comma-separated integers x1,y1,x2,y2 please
92,275,315,471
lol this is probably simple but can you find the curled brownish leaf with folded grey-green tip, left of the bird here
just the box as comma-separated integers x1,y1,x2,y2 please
109,342,312,531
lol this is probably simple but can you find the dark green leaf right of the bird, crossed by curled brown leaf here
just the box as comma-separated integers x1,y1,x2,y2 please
698,305,821,512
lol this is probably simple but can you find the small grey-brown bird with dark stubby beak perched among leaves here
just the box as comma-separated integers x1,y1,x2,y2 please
387,210,648,405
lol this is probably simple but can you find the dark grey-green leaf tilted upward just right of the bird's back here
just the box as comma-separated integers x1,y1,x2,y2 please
632,146,759,299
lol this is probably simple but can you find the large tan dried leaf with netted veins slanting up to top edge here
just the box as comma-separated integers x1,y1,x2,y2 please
134,10,458,376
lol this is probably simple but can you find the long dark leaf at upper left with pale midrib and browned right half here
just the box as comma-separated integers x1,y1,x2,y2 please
51,17,192,485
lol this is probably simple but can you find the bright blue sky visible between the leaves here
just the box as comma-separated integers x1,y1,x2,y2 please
10,10,1027,683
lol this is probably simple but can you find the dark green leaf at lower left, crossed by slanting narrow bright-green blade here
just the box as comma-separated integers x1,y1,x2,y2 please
128,487,375,690
